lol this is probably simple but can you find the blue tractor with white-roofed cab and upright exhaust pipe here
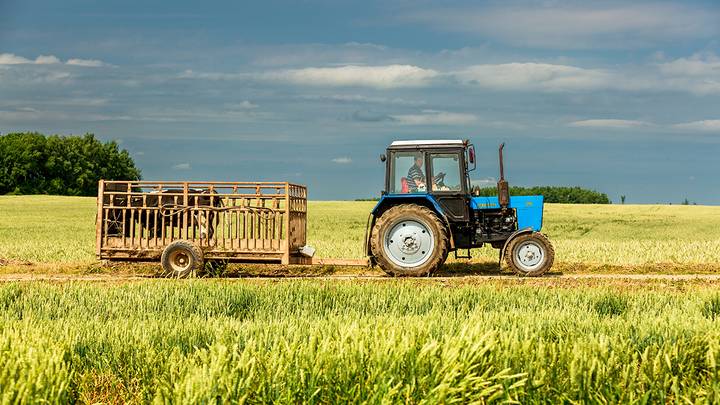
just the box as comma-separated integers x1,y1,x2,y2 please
366,140,555,276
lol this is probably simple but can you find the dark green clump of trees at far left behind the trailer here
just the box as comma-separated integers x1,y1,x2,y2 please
0,132,140,196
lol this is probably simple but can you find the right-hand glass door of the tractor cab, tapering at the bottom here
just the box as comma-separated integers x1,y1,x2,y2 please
427,150,470,222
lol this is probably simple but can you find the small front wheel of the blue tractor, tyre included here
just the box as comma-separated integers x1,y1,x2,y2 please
505,232,555,277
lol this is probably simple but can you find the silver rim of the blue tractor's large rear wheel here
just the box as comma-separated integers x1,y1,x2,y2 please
384,219,435,268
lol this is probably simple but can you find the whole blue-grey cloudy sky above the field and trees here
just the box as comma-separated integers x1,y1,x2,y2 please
0,0,720,204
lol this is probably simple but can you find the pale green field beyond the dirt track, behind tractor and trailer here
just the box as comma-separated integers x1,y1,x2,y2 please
0,196,720,271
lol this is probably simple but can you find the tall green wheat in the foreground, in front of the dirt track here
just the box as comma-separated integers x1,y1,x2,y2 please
0,280,720,403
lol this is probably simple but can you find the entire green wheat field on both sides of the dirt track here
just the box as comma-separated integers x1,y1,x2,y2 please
0,196,720,404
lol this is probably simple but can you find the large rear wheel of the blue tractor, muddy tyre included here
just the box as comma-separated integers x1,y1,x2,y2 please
370,204,449,276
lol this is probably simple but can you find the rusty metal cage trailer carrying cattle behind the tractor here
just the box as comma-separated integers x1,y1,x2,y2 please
95,180,312,276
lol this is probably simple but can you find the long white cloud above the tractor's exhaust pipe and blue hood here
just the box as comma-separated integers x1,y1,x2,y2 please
454,63,615,91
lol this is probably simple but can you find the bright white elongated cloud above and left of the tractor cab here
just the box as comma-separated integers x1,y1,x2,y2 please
261,65,438,89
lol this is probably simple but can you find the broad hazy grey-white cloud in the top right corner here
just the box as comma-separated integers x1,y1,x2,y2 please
404,1,720,49
